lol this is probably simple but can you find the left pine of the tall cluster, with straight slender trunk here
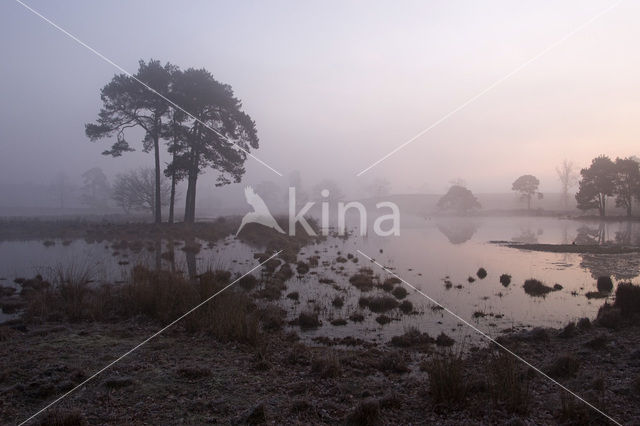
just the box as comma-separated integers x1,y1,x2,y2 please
85,60,176,223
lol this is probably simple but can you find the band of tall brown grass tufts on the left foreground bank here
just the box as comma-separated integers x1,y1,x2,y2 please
25,266,259,344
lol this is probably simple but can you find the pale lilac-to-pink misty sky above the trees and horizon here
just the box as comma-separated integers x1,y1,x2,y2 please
0,0,640,196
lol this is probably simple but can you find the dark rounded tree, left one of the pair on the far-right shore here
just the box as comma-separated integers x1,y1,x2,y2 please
576,155,616,216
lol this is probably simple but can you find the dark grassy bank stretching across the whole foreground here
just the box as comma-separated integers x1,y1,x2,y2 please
0,248,640,424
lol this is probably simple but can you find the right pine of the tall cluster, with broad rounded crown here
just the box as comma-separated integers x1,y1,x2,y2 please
170,68,258,223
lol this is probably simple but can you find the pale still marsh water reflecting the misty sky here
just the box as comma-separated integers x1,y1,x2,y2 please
0,217,640,340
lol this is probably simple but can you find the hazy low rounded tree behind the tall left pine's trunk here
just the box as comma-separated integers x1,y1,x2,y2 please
111,169,171,218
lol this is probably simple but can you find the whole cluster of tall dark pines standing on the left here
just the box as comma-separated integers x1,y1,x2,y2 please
85,60,258,223
